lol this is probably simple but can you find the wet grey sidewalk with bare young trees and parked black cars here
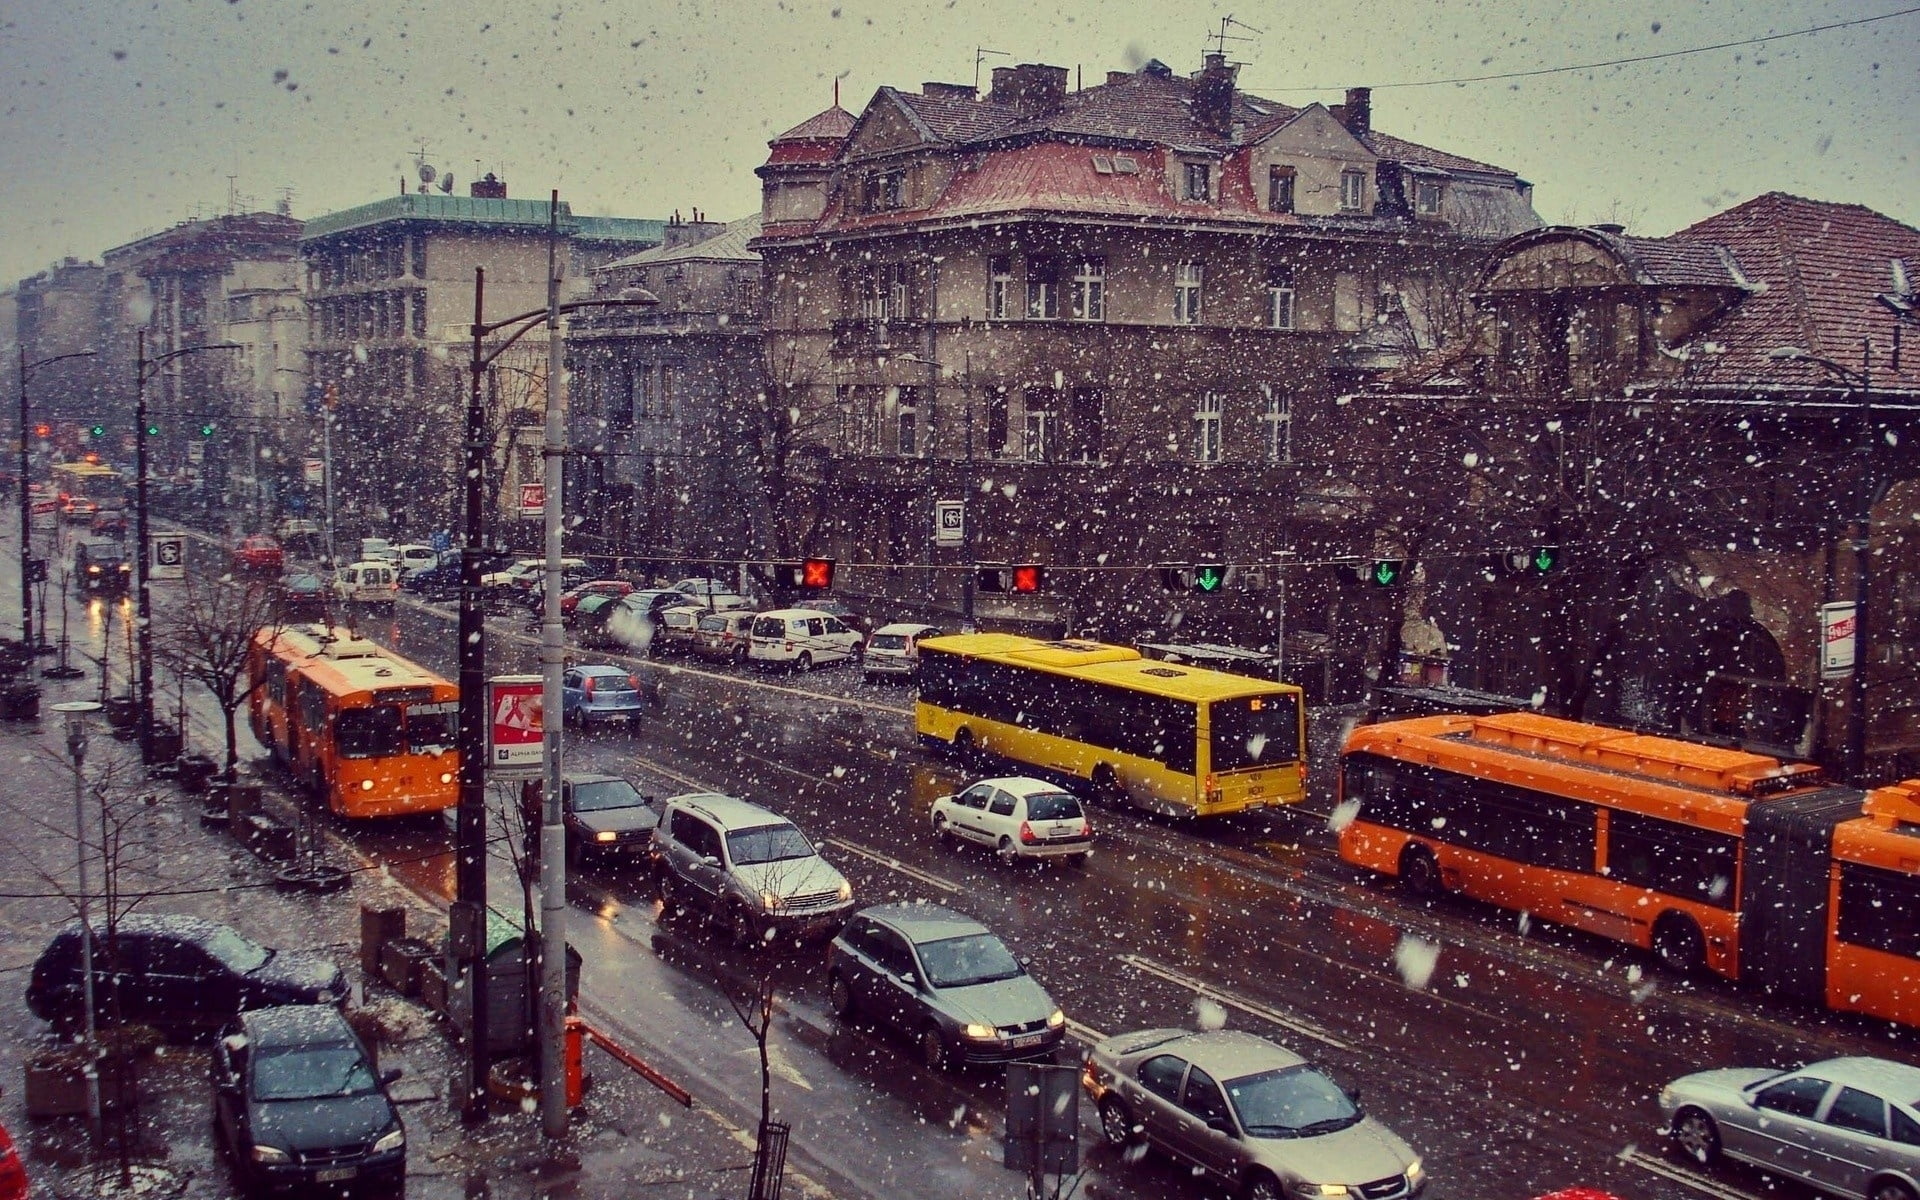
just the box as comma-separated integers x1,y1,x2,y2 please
0,680,824,1200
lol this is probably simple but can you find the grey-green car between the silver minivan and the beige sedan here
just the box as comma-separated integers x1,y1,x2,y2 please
828,902,1066,1071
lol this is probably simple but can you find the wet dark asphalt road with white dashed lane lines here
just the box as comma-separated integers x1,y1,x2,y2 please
18,522,1920,1200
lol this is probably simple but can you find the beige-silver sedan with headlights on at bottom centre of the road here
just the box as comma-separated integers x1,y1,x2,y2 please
1081,1029,1427,1200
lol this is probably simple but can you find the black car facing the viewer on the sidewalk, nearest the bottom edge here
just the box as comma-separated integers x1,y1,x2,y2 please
213,1004,407,1194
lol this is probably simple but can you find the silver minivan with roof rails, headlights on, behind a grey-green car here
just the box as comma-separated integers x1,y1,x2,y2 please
653,793,852,947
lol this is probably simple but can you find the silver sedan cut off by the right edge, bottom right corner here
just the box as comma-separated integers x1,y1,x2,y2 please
1661,1058,1920,1200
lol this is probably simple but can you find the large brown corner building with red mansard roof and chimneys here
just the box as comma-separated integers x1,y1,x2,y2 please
755,56,1540,643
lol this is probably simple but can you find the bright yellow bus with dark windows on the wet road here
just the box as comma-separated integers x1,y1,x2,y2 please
914,634,1308,816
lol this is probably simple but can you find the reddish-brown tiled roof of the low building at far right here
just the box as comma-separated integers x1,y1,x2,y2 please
1670,192,1920,388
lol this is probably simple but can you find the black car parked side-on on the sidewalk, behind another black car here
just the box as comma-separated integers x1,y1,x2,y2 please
27,914,348,1033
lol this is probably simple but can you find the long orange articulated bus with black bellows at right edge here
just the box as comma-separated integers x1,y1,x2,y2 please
1338,712,1920,1025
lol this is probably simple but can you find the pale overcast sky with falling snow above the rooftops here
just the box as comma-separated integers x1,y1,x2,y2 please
0,0,1920,286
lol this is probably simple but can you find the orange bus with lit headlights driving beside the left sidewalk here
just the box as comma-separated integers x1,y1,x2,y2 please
248,624,461,818
